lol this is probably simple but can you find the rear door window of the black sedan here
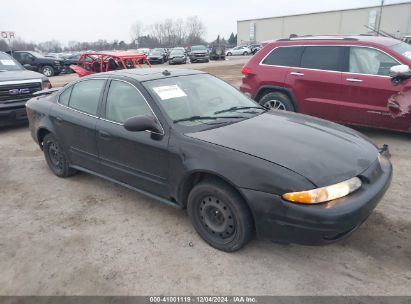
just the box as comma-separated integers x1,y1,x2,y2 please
69,79,105,115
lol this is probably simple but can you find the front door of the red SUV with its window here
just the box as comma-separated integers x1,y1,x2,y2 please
339,46,411,131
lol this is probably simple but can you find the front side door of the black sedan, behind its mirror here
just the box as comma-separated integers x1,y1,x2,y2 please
97,79,169,197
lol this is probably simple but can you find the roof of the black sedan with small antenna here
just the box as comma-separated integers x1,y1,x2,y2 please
85,68,207,82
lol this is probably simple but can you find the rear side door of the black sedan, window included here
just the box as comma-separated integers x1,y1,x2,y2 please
51,79,106,172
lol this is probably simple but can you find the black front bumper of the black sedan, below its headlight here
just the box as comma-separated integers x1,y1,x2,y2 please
241,156,392,245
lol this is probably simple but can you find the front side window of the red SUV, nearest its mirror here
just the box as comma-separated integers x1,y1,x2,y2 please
349,47,399,76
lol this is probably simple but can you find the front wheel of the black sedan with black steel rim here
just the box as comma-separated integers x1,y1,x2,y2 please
187,180,254,252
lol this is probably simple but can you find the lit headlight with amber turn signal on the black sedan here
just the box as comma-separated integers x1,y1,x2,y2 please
282,177,362,204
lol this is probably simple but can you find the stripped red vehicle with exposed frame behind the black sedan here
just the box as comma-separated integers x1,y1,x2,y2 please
70,52,151,77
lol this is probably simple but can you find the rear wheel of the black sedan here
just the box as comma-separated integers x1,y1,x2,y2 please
43,133,77,177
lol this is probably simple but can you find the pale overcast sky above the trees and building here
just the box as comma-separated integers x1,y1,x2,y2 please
0,0,406,44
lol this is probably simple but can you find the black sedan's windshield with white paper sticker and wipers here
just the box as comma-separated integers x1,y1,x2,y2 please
143,74,265,126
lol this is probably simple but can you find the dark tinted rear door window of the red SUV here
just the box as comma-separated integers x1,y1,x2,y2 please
301,46,343,71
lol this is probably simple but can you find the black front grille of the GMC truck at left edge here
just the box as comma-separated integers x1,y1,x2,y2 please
0,80,42,104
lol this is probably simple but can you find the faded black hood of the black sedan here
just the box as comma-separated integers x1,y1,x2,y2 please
187,111,378,187
